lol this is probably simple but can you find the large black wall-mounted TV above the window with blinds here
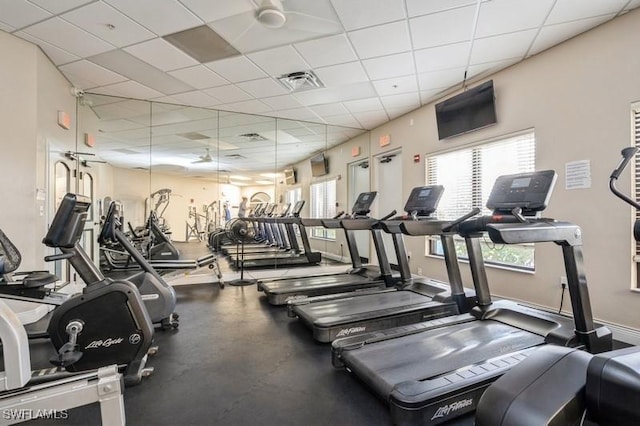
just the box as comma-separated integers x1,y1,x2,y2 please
436,80,496,139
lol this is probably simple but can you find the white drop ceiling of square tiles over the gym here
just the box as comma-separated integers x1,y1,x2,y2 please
5,0,640,181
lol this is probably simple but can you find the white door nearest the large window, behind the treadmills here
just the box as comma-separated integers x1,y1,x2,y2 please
373,151,404,265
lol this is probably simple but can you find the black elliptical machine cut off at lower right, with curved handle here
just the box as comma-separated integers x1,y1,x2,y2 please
476,147,640,426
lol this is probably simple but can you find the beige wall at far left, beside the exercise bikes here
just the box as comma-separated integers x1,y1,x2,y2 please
0,31,75,269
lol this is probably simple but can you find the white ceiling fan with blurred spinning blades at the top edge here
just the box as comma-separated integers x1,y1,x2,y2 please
210,0,344,52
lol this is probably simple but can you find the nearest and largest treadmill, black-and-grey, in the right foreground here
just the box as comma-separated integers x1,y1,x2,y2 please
332,170,612,425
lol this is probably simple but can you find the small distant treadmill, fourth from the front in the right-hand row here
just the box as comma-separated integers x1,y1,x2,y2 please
231,201,322,269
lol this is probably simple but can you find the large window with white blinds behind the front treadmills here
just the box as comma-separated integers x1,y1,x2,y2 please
426,132,535,270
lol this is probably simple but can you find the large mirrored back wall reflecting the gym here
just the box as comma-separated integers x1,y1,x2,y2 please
69,94,370,267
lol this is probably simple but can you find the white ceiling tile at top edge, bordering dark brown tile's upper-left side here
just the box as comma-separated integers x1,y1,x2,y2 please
104,0,202,36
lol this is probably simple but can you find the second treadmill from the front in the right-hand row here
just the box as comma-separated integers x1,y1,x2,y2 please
289,185,477,342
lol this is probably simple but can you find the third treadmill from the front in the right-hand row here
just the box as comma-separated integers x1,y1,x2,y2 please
258,192,395,305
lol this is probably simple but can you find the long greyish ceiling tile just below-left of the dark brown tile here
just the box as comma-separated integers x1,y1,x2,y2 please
88,50,193,95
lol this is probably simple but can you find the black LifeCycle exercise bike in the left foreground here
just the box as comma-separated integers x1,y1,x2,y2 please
0,194,154,385
